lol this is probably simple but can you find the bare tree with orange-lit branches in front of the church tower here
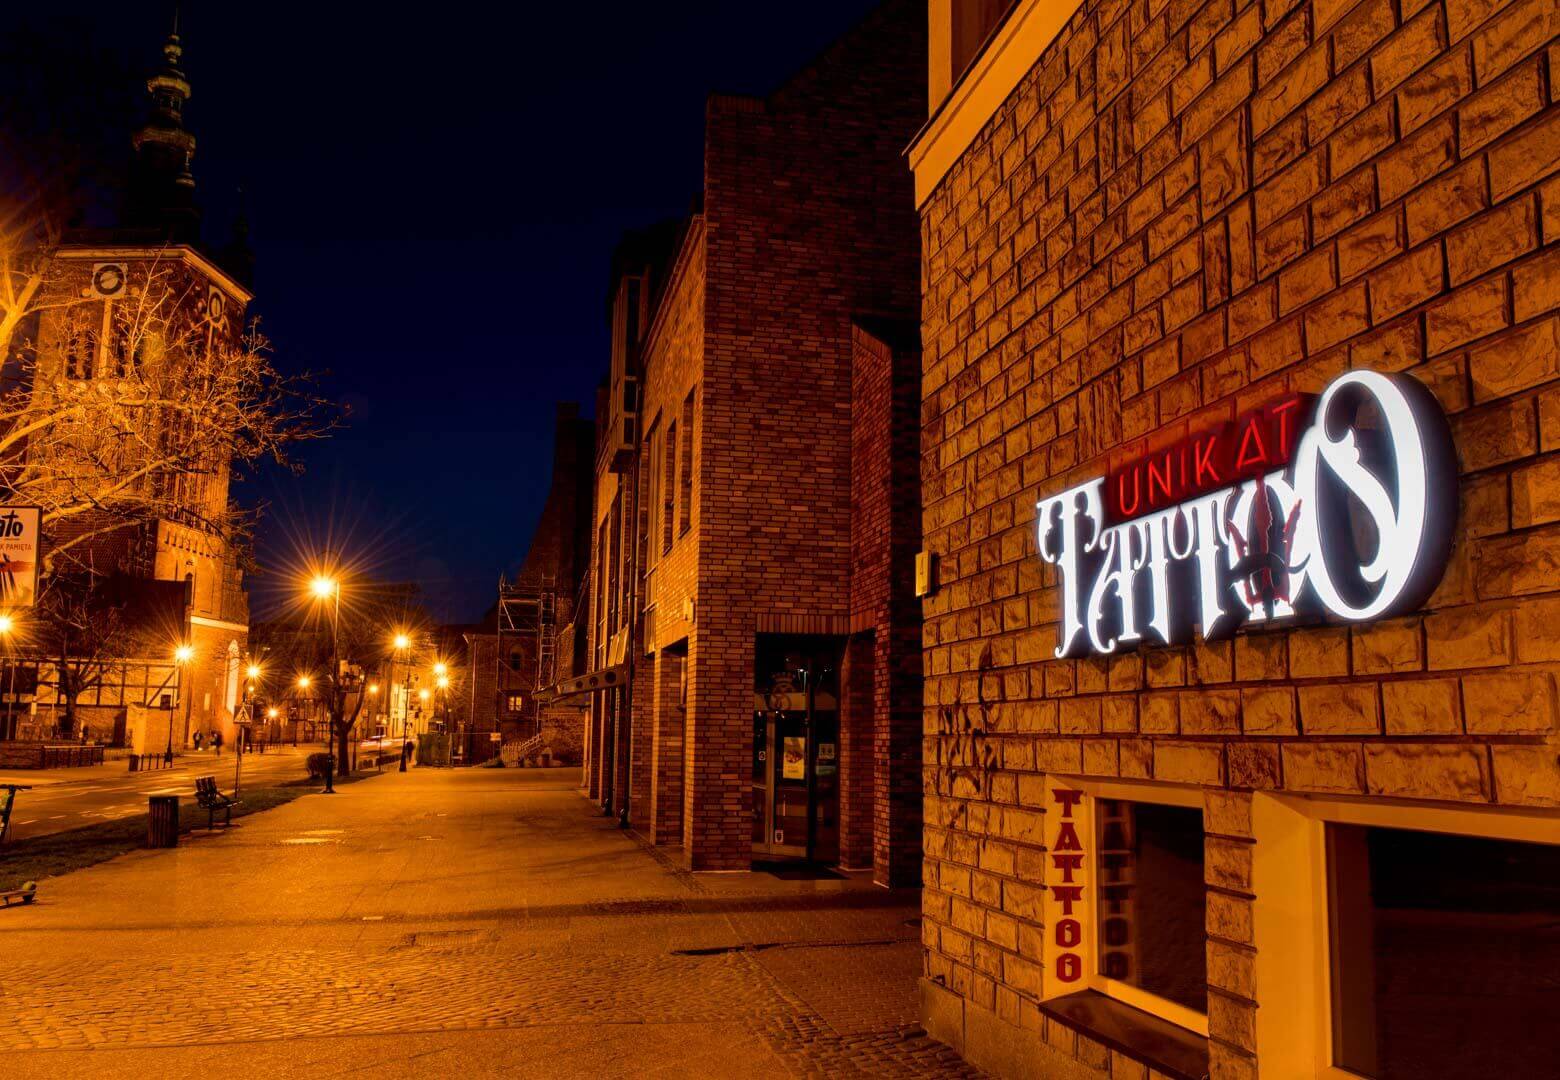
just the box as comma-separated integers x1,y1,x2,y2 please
0,215,335,568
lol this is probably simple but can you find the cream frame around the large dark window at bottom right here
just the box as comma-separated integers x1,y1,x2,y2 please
1251,791,1560,1080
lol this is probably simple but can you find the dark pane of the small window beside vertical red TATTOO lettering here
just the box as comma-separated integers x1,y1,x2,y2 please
1095,799,1207,1013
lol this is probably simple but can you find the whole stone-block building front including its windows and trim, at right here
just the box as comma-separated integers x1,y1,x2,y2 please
909,0,1560,1077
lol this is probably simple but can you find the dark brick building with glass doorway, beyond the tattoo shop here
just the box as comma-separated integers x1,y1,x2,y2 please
587,3,925,883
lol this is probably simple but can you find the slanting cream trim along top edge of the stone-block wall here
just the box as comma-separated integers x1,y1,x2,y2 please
906,0,1083,206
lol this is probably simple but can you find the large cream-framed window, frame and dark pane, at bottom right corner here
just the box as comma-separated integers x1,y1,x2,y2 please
1251,793,1560,1080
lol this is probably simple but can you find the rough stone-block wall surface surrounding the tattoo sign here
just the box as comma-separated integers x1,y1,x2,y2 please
922,0,1560,1077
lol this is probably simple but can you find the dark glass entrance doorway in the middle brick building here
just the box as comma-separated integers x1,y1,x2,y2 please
752,634,844,863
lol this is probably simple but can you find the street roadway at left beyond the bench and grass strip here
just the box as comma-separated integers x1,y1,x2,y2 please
0,746,320,841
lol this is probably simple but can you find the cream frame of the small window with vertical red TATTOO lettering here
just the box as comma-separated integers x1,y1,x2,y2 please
1045,774,1207,1038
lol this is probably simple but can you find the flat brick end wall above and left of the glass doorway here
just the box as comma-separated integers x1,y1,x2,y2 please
685,0,925,868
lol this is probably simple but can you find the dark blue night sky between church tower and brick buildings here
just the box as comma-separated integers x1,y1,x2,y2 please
0,0,872,621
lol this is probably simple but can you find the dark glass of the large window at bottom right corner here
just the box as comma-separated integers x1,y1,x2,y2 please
1328,824,1560,1080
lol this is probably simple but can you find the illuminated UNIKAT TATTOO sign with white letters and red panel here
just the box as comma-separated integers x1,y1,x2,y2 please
1037,371,1457,657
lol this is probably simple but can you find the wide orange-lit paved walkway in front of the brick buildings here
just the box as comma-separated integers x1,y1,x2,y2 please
0,769,970,1078
